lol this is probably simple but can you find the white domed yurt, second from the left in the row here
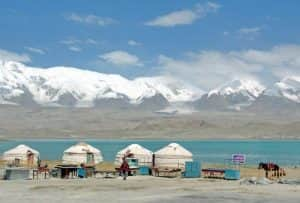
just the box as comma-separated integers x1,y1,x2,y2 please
62,142,103,164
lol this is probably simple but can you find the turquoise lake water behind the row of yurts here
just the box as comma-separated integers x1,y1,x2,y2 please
0,140,300,166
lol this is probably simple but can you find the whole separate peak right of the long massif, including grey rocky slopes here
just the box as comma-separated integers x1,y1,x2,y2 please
192,79,265,110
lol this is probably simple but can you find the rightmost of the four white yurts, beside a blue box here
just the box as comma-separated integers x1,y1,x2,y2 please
154,143,193,169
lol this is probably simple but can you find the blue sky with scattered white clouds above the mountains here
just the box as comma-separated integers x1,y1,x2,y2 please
0,0,300,87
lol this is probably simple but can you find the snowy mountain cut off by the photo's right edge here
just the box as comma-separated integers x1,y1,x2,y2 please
264,76,300,103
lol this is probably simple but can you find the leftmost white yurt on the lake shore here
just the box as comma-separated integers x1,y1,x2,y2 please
2,144,40,164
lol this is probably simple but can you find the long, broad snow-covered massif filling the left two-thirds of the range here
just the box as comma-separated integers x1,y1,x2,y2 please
0,61,201,107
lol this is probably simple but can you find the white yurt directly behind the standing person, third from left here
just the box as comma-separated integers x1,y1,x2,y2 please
115,144,153,166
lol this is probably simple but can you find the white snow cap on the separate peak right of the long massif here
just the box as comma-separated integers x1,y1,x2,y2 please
208,79,265,100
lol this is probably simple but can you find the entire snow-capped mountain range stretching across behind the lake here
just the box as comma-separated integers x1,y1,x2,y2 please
0,61,300,111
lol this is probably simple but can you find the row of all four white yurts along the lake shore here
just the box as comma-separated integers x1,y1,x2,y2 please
2,142,193,168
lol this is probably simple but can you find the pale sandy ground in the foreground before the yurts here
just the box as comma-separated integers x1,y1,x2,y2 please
0,176,300,203
